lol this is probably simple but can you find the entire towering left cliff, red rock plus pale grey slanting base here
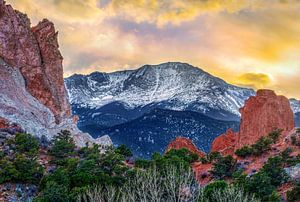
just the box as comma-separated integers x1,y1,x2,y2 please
0,0,110,145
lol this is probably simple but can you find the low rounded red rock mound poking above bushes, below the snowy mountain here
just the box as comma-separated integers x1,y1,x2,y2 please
165,137,205,156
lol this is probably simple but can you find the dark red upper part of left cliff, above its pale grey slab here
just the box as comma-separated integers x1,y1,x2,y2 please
0,0,71,123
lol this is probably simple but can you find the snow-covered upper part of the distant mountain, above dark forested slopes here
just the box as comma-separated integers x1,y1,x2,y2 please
65,62,255,119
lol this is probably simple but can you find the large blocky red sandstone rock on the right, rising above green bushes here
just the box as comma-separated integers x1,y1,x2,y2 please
236,90,295,149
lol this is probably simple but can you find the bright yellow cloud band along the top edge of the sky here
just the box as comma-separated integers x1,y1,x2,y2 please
108,0,260,26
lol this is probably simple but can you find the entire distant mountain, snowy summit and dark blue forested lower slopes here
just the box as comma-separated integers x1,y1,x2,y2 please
65,62,300,157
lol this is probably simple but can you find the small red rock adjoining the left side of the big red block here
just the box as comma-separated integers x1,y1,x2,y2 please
211,129,237,156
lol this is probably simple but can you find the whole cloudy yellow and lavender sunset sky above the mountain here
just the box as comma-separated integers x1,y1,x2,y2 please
7,0,300,99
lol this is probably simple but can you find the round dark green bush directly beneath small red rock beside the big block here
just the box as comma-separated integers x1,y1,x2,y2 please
211,155,236,179
